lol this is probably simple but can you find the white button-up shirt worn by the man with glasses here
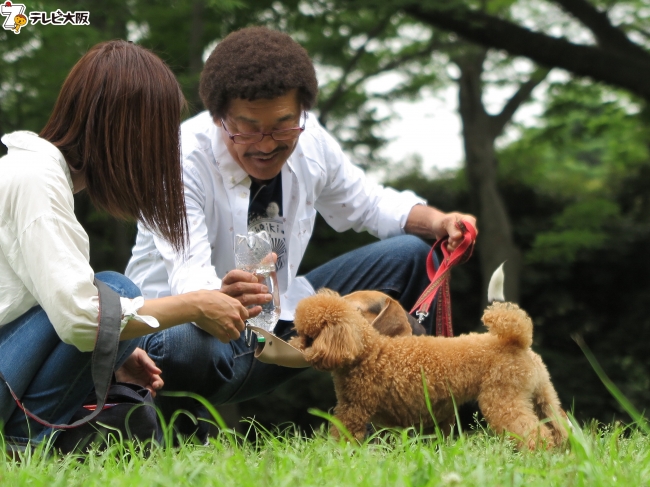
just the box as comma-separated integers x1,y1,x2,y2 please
126,111,426,320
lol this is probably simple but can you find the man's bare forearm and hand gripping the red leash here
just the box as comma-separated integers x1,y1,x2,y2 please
404,205,476,251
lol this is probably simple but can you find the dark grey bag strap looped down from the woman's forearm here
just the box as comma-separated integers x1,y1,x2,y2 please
0,279,122,429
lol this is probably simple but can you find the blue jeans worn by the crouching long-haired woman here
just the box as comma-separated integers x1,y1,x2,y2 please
0,272,141,448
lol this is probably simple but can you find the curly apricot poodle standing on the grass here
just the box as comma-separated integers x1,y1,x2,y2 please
291,291,567,449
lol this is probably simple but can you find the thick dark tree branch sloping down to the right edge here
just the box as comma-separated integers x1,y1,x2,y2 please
403,4,650,101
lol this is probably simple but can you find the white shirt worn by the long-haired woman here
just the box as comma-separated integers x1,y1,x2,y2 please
0,131,158,351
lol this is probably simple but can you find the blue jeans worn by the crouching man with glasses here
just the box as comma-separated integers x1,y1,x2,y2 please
141,236,433,433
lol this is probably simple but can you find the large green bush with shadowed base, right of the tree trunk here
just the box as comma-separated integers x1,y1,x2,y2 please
492,82,650,428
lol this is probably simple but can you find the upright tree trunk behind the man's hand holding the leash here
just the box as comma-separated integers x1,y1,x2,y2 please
454,49,521,302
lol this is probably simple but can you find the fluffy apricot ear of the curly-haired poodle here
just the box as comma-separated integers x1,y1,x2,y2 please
304,319,368,370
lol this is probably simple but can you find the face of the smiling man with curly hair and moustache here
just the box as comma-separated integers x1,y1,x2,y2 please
215,90,301,181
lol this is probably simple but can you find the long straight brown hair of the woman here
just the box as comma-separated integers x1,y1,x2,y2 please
40,40,188,254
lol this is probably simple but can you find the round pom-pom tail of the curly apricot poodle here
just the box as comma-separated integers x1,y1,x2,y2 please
482,302,533,348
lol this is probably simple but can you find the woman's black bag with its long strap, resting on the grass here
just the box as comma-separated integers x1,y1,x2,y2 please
0,279,161,452
